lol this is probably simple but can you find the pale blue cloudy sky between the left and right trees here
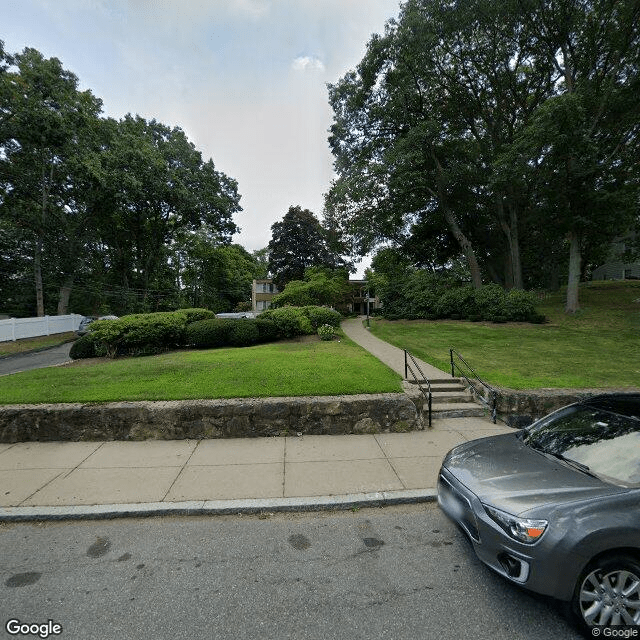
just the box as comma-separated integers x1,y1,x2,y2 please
5,0,399,277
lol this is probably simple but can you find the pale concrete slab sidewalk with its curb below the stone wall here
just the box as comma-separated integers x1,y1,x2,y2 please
0,418,513,521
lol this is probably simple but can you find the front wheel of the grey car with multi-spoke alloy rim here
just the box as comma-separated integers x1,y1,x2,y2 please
573,554,640,628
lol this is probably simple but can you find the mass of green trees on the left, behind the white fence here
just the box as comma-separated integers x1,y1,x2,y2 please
0,44,246,315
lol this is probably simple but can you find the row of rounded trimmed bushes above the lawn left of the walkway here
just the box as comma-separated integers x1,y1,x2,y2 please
70,307,341,359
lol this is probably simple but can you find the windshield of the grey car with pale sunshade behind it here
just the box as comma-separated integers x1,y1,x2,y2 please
522,406,640,485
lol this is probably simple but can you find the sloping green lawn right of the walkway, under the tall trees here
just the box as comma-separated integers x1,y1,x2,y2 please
371,282,640,389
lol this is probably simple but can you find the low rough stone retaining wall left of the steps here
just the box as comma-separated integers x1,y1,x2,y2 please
0,393,424,443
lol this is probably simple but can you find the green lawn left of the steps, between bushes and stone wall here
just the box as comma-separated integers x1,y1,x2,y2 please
0,336,402,404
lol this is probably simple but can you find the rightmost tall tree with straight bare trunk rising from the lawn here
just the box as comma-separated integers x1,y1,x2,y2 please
508,0,640,313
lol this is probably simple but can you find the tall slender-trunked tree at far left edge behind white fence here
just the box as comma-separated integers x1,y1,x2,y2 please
0,48,102,316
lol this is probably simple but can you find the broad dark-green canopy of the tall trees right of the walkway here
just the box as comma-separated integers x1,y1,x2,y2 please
325,0,640,311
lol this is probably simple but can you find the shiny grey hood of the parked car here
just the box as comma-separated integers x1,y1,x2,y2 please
443,433,625,515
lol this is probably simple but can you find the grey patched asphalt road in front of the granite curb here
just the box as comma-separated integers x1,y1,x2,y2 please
0,504,579,640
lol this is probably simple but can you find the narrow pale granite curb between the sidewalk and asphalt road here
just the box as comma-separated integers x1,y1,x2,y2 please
0,489,437,522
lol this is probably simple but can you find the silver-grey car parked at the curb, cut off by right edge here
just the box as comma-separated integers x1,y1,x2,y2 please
438,394,640,631
